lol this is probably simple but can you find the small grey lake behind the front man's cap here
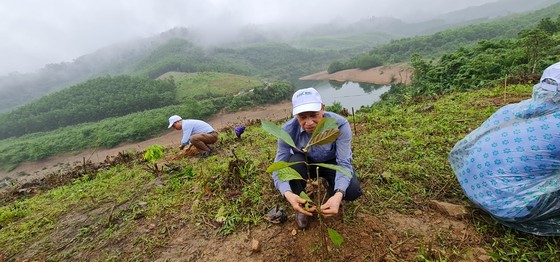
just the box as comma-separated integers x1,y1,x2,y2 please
301,81,391,112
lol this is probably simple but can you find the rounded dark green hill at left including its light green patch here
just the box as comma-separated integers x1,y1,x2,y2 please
0,72,264,139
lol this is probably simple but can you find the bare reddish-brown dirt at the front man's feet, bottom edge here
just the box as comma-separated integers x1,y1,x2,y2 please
153,207,491,261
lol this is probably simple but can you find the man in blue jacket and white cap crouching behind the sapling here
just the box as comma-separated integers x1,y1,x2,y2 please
273,88,362,229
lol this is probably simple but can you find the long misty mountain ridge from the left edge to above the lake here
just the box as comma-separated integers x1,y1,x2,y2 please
0,28,350,112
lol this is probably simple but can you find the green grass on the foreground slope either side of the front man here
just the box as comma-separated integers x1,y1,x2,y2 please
0,86,559,261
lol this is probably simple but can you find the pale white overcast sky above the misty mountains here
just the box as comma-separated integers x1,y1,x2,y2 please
0,0,497,75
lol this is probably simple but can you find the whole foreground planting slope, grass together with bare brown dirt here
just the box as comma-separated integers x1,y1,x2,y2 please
0,85,560,261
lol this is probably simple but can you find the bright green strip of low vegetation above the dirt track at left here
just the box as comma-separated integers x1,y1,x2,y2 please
0,100,217,171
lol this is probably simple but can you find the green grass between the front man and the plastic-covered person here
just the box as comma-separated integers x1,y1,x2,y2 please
354,86,531,212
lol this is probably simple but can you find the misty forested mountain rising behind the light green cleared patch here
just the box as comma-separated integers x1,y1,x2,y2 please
133,39,348,81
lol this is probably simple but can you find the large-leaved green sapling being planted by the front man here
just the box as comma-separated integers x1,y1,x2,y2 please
262,117,352,249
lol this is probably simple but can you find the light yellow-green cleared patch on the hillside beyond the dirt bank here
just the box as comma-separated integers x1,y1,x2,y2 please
159,72,263,100
